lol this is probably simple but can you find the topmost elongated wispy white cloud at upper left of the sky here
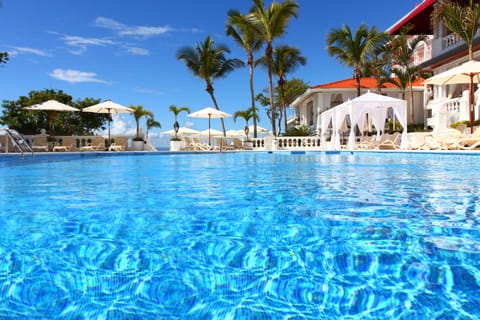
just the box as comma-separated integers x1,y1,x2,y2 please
93,17,174,37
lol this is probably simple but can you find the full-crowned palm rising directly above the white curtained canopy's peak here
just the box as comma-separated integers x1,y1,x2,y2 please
327,24,386,97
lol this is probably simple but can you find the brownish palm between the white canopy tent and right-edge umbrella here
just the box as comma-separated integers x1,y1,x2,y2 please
389,28,427,128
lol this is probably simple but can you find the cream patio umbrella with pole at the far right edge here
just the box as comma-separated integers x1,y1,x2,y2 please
424,60,480,133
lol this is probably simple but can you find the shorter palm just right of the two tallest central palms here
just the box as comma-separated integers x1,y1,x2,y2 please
258,45,307,131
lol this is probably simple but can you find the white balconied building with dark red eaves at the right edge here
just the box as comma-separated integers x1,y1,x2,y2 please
387,0,480,132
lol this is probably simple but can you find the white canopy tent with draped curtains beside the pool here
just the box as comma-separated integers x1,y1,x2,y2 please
320,91,407,149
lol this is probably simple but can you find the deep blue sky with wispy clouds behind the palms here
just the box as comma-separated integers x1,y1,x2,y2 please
0,0,421,146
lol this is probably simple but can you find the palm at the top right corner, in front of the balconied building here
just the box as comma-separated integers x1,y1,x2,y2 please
431,0,480,133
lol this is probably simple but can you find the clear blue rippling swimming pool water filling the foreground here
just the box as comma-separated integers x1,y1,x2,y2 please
0,152,480,320
